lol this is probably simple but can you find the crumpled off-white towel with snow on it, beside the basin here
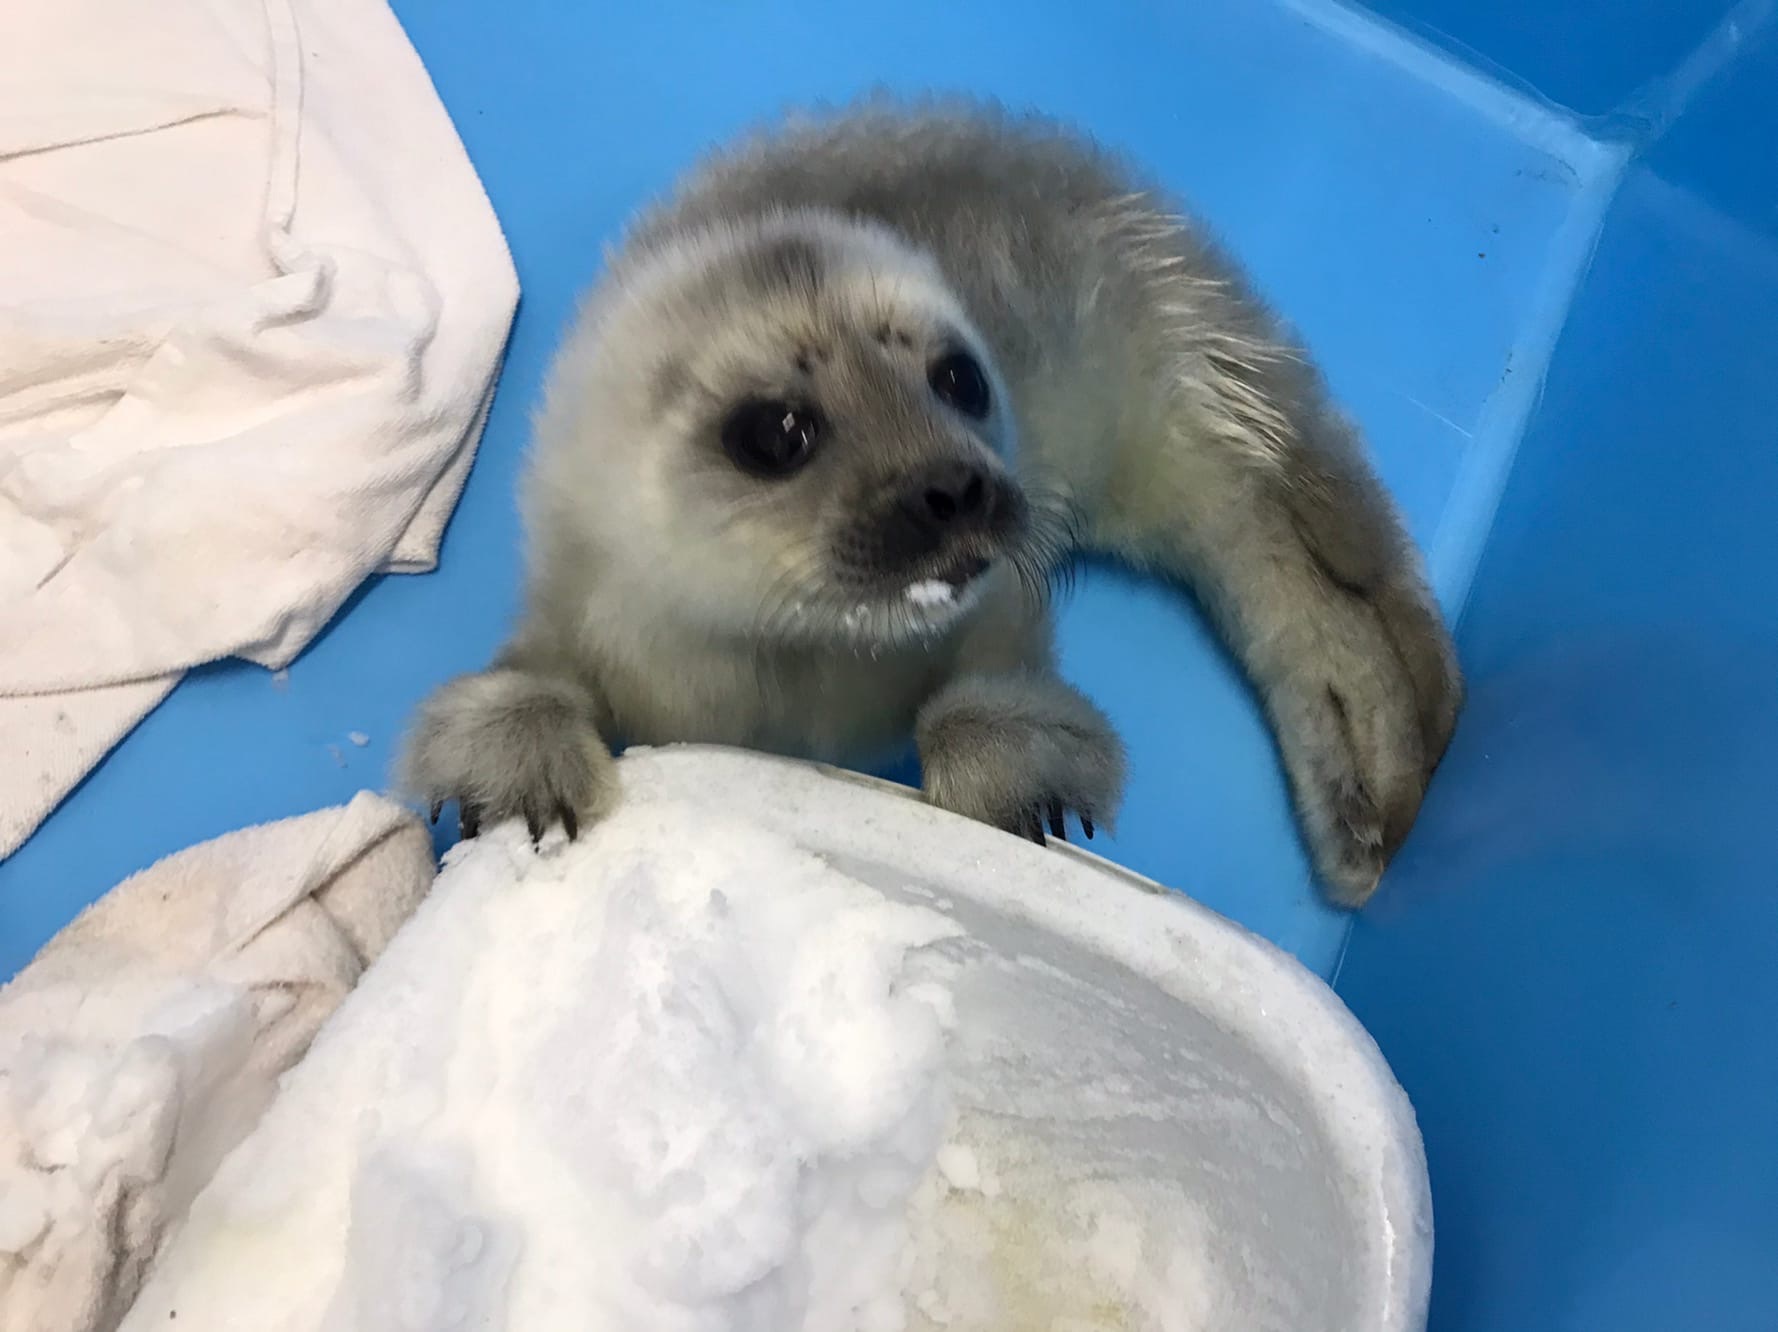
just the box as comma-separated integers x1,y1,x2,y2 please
0,791,434,1332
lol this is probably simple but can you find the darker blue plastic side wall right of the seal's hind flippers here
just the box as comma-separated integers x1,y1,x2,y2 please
1337,5,1778,1332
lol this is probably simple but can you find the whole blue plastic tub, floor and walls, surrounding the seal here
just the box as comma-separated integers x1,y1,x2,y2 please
0,0,1778,1332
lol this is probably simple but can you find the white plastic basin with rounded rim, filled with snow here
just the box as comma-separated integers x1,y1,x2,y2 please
124,749,1431,1332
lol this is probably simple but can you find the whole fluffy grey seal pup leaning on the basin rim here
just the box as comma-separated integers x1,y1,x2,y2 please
404,103,1462,903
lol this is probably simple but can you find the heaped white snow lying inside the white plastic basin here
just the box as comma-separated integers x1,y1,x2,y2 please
124,802,1251,1332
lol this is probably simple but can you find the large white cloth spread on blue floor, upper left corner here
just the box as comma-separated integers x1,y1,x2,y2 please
0,0,517,855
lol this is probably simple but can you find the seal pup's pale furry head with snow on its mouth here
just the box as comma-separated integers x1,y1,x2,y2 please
532,212,1044,646
